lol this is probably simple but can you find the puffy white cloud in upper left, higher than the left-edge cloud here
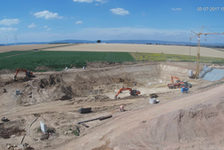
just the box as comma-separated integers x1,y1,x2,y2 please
34,10,62,19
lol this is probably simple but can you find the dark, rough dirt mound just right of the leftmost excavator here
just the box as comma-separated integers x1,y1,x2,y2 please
16,74,73,106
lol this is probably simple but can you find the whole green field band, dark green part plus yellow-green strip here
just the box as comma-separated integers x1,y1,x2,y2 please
0,51,224,71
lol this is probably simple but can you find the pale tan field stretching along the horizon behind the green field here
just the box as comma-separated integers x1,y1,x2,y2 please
46,44,224,58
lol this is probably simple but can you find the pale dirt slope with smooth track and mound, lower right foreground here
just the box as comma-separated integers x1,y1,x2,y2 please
58,85,224,150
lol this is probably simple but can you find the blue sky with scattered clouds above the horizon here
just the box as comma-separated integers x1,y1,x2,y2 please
0,0,224,43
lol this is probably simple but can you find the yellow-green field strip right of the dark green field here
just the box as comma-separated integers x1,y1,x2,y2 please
131,53,224,64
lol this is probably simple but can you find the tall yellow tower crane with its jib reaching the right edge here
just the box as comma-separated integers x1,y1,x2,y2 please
193,32,224,78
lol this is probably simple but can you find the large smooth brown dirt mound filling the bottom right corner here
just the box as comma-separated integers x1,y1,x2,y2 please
113,97,224,150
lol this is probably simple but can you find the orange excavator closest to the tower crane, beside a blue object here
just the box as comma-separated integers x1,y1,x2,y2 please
167,76,192,89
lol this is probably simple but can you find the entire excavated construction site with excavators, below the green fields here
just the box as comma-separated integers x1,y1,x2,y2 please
0,40,224,150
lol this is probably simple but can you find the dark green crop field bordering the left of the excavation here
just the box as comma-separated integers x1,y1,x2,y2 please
0,51,135,71
